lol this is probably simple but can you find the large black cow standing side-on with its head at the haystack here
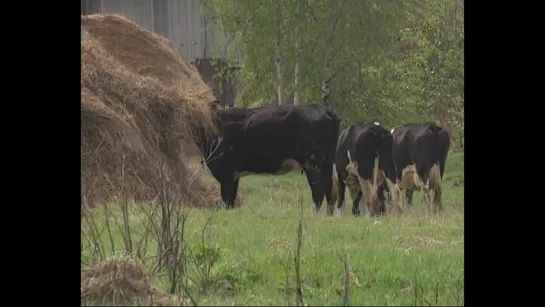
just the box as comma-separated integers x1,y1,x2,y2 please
195,105,340,215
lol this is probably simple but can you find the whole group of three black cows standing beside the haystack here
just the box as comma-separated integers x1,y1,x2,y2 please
195,101,450,216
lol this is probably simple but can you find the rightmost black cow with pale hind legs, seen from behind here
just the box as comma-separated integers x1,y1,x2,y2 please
391,122,450,213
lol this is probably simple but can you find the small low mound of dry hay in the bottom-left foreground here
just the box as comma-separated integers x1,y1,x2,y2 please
81,256,184,306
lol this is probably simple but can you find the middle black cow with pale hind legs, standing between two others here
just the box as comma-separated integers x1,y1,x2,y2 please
335,123,396,216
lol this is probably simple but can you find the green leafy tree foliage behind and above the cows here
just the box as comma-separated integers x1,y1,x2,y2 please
203,0,464,146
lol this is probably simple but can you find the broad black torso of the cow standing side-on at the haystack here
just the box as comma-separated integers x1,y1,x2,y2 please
223,105,338,173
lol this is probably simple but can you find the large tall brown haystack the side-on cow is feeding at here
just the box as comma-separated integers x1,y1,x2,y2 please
81,15,218,206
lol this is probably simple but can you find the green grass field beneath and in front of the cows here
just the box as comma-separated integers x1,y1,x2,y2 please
82,153,464,306
